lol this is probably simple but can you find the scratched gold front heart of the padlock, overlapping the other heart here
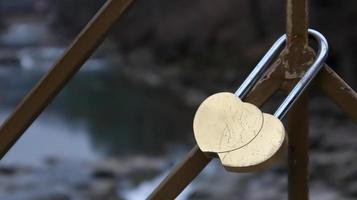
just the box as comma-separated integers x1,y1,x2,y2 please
193,93,263,153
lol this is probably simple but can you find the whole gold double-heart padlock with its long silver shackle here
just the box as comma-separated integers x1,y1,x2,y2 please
193,29,328,172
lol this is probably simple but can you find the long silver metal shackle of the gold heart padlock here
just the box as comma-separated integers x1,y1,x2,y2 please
235,29,328,119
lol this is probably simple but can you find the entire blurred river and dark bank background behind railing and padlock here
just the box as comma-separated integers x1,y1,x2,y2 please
0,0,357,200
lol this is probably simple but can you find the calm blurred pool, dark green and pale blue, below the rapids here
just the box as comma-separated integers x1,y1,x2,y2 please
0,64,190,164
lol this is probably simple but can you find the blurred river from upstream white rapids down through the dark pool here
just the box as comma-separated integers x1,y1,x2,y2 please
0,15,189,164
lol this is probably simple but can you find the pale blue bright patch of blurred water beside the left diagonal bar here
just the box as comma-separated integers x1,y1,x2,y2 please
0,111,98,167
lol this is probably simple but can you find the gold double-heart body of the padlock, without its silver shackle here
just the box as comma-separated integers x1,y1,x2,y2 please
193,92,286,172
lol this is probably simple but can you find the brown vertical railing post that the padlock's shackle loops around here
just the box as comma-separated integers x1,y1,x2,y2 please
282,0,313,200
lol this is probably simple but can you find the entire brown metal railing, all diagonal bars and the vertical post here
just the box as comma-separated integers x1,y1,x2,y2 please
0,0,357,200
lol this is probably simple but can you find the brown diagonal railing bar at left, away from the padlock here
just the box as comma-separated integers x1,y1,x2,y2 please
0,0,133,158
